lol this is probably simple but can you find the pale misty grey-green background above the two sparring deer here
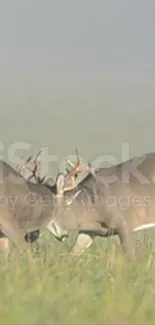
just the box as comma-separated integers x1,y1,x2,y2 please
0,0,155,176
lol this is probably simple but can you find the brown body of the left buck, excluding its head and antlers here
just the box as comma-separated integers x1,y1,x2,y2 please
0,161,67,250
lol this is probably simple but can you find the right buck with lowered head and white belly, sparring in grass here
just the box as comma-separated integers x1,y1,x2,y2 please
47,152,155,260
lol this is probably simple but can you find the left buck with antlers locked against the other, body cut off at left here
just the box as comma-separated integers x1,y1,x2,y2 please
0,147,88,258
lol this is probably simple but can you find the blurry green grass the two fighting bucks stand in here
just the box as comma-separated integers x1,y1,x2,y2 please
0,231,155,325
